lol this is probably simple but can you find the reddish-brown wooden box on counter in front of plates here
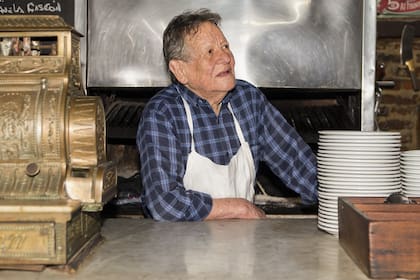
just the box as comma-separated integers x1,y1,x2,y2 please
338,197,420,279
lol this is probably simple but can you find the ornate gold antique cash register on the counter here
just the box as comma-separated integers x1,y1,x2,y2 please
0,15,117,269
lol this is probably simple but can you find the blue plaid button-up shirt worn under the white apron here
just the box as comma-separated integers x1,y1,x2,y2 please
137,80,317,221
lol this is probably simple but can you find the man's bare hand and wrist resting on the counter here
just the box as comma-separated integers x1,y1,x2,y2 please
206,198,265,220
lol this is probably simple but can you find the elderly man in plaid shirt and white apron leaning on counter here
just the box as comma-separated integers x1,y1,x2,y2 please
137,9,317,221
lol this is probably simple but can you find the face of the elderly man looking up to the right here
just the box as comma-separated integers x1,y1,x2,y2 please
171,22,235,100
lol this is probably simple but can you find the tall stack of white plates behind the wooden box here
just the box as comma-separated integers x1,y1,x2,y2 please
317,130,401,235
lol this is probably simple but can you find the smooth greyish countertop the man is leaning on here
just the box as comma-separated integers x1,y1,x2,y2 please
0,218,369,280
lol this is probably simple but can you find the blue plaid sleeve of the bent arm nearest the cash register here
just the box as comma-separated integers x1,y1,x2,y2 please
137,102,212,221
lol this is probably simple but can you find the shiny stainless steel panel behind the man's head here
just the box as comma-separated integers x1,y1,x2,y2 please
87,0,364,90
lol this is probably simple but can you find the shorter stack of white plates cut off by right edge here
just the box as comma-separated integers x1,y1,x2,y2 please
400,150,420,197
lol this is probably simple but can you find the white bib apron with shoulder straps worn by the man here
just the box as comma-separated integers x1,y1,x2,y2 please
182,98,255,202
